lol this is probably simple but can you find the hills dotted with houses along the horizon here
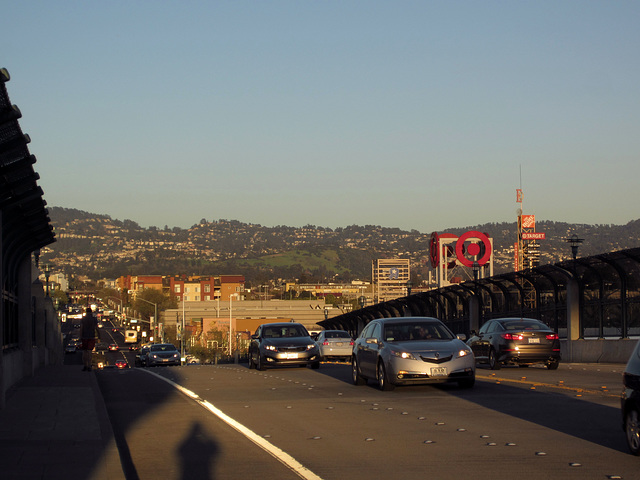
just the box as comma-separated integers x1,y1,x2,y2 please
42,207,640,284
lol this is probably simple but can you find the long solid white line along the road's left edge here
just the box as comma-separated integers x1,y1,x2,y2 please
142,369,322,480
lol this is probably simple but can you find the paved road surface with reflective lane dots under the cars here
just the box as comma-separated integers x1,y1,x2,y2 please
97,364,640,480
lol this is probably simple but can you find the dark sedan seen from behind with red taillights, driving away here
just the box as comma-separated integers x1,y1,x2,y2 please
467,318,561,370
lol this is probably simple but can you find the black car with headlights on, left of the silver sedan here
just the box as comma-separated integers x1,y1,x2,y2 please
249,322,320,370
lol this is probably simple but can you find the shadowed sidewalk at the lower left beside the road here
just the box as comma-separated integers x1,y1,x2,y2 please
0,365,125,480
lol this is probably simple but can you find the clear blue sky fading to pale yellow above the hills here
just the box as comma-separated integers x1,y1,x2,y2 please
0,0,640,233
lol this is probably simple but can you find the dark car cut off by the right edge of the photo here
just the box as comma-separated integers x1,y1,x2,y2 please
621,342,640,455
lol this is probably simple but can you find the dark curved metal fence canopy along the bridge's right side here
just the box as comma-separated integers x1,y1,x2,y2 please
318,248,640,338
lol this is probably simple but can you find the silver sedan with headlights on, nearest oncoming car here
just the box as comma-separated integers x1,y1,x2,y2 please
351,317,476,390
